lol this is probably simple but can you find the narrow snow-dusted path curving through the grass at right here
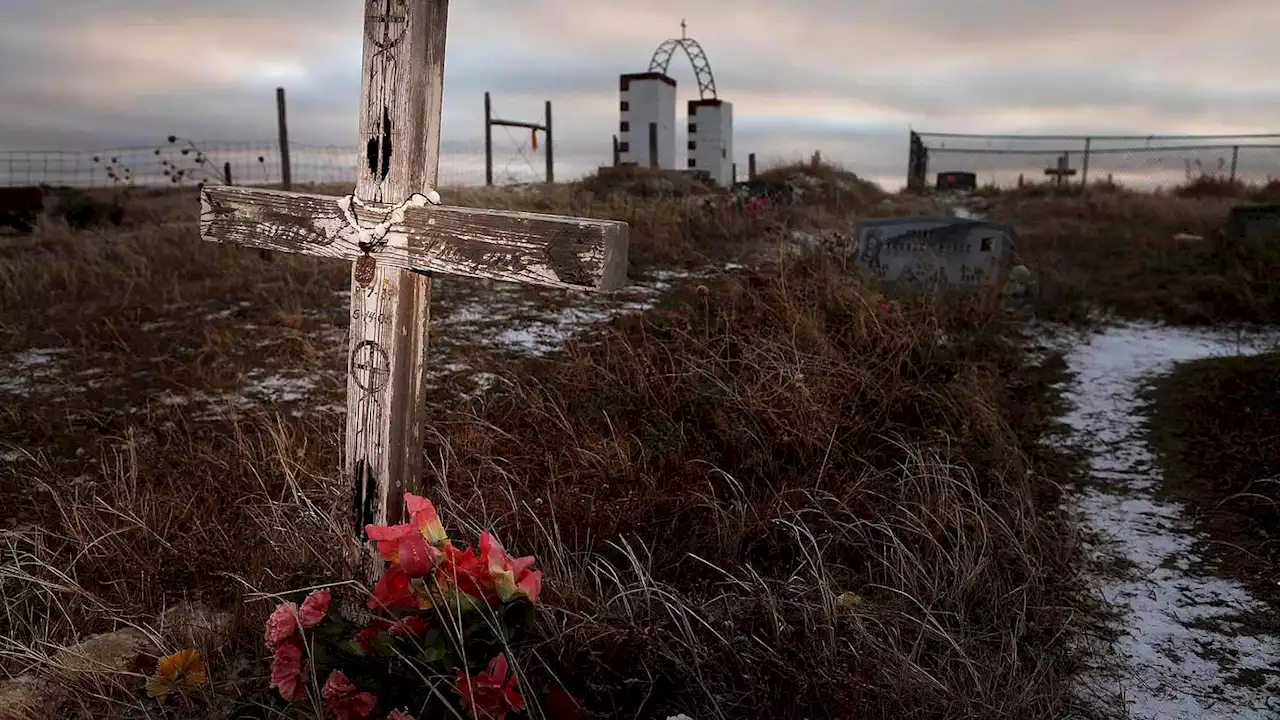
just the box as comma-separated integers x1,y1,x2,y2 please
1044,324,1280,720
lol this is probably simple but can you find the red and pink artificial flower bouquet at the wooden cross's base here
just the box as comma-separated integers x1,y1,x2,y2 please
266,493,562,720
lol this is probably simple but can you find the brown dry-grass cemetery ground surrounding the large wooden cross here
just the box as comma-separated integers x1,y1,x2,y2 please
0,168,1280,720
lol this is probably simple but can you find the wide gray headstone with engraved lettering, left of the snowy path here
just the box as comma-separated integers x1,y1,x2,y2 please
854,217,1016,290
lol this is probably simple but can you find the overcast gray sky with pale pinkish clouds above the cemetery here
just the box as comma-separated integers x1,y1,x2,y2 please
0,0,1280,184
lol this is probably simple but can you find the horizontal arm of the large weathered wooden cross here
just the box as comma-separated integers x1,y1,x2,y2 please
200,186,627,292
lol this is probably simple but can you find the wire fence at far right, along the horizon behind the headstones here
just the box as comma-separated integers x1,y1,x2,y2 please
910,132,1280,190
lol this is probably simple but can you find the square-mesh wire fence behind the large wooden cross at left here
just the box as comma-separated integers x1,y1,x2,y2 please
0,138,555,187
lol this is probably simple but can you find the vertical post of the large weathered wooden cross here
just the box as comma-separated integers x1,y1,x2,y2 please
343,0,449,577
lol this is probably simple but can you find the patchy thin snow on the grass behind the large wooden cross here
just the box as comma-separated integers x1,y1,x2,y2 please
0,265,741,427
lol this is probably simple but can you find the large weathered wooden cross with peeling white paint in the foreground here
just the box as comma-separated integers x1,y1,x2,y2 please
200,0,627,579
